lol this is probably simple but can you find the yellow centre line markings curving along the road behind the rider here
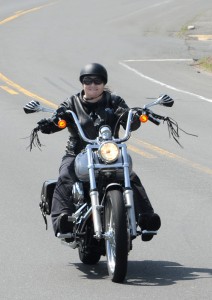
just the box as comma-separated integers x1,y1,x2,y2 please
0,3,212,175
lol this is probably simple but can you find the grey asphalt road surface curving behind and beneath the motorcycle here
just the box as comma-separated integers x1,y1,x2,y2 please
0,0,212,300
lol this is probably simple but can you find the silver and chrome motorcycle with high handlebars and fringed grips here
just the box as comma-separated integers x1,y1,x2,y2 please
24,95,179,283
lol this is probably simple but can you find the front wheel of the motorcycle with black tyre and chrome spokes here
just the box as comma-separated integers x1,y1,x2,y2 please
104,190,128,282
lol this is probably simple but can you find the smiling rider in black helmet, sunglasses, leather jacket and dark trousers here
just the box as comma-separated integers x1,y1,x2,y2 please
38,63,161,241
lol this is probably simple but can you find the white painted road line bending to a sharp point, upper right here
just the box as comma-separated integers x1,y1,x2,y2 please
119,59,212,103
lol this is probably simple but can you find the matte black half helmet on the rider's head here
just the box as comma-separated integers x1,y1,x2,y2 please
79,63,107,84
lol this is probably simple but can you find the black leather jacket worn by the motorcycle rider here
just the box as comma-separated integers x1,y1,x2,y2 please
51,91,140,156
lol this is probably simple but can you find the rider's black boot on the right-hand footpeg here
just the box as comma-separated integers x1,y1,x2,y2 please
138,213,161,242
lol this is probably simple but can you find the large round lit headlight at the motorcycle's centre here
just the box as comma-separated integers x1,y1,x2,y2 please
98,142,119,163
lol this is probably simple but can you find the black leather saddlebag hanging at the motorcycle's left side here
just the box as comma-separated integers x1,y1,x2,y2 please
40,179,57,215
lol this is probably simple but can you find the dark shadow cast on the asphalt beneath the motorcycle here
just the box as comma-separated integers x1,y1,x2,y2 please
70,260,212,286
